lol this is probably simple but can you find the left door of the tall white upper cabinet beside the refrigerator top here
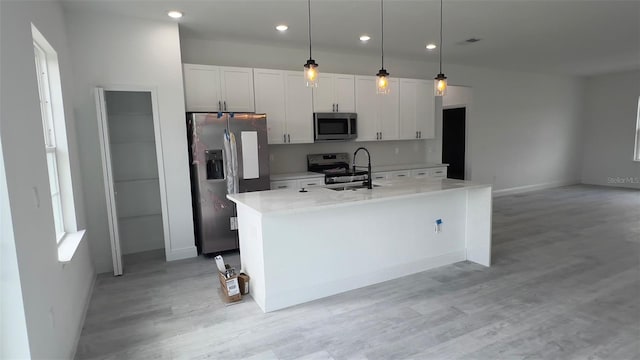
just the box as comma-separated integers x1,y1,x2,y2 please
253,69,287,144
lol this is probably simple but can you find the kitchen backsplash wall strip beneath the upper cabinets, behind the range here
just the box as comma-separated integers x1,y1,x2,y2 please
269,140,440,174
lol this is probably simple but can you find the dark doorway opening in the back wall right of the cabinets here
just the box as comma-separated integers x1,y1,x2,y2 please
442,107,467,180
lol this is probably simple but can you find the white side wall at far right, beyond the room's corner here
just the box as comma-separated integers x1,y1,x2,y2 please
582,71,640,189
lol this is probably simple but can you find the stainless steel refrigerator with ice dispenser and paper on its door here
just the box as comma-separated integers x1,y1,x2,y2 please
187,113,270,254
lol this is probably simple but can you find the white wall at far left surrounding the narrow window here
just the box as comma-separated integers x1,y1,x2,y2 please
0,1,95,359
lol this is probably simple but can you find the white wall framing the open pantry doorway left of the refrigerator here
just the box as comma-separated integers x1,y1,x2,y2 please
66,11,196,272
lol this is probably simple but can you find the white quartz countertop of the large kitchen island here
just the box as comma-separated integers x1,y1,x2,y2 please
227,178,491,215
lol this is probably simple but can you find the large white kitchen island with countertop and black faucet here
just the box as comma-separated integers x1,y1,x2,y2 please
227,179,491,312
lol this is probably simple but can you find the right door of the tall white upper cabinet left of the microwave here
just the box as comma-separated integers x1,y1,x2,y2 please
284,71,313,144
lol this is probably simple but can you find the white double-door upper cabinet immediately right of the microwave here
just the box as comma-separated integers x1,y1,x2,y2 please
355,76,399,141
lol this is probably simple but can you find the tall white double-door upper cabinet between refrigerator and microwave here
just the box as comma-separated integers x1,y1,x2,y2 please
254,69,313,144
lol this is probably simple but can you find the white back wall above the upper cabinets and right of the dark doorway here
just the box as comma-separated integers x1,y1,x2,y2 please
181,39,583,190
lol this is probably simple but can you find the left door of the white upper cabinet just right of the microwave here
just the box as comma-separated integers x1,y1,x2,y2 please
355,76,380,141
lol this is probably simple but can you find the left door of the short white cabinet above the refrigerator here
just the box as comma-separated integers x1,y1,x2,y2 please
183,64,221,112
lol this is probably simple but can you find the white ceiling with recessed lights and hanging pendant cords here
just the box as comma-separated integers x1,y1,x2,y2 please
63,0,640,75
